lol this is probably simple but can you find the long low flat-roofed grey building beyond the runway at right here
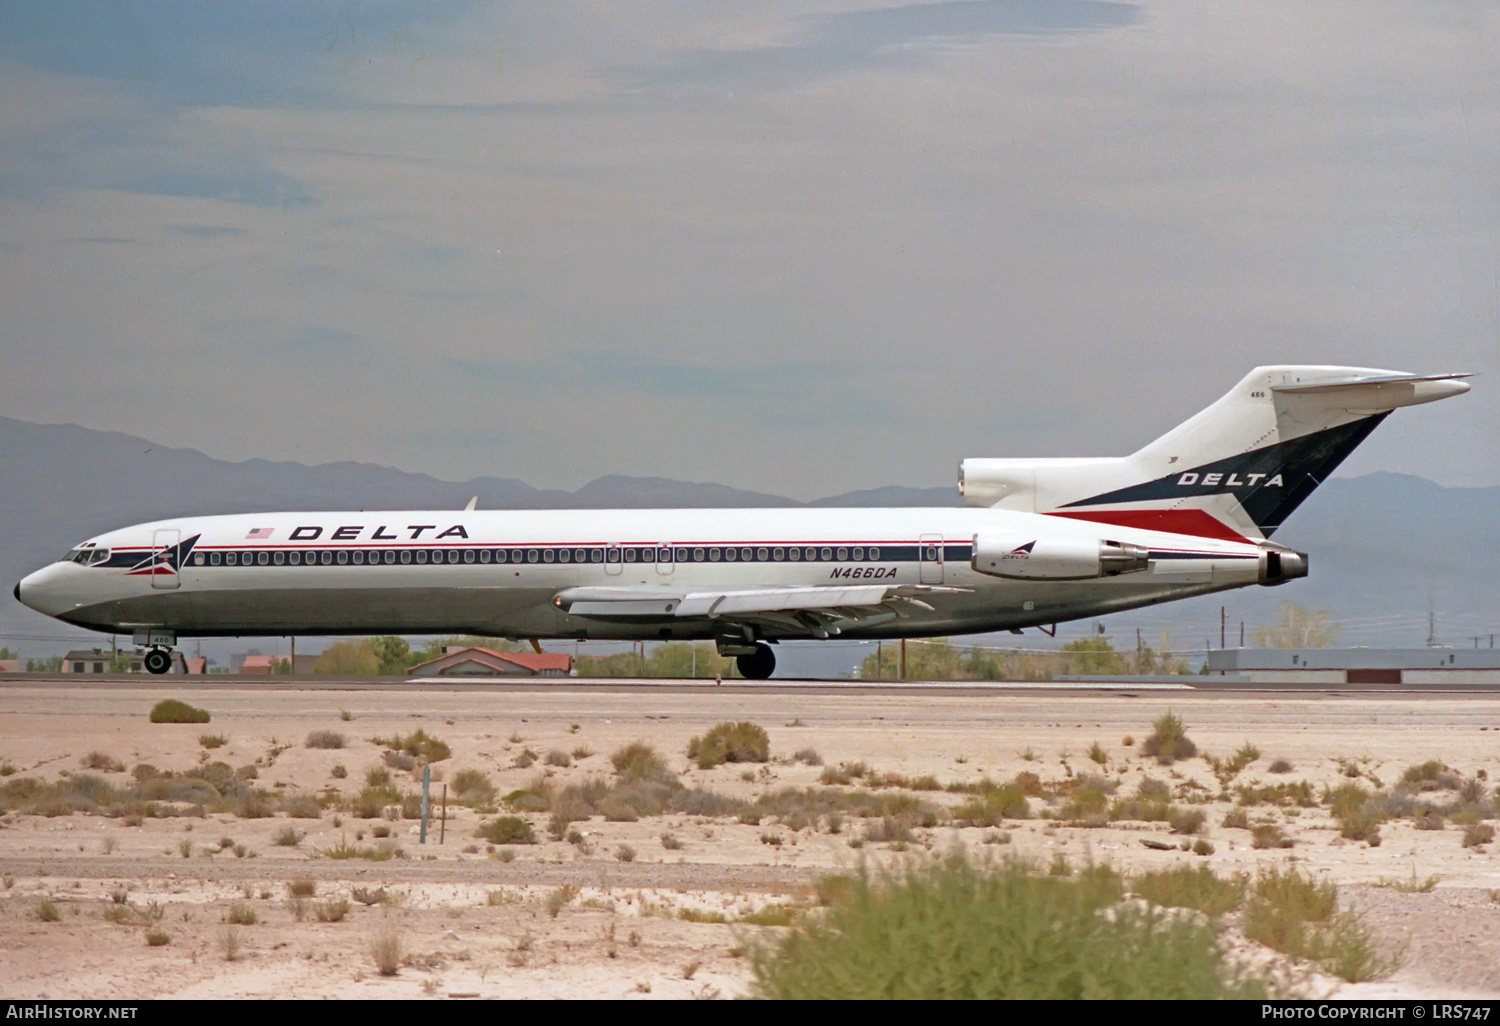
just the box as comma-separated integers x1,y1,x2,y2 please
1209,648,1500,689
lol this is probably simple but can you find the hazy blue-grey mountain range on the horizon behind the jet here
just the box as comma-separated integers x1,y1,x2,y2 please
0,417,1500,656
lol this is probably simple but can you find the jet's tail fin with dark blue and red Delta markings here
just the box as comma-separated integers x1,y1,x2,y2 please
959,366,1469,540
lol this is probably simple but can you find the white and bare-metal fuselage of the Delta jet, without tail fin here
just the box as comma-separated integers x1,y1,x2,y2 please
17,509,1266,639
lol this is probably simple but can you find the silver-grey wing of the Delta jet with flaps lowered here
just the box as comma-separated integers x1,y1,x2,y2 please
552,585,959,636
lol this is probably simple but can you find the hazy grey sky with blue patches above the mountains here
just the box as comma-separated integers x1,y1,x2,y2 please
0,0,1500,498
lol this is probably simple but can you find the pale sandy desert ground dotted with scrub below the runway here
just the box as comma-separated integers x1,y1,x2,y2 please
0,678,1500,999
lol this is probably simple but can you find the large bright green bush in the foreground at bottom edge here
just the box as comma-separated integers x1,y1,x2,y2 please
750,855,1269,1001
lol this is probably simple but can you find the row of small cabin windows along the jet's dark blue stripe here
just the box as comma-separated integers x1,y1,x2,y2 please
192,546,881,567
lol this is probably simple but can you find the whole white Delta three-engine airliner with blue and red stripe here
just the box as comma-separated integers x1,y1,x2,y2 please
15,366,1469,678
